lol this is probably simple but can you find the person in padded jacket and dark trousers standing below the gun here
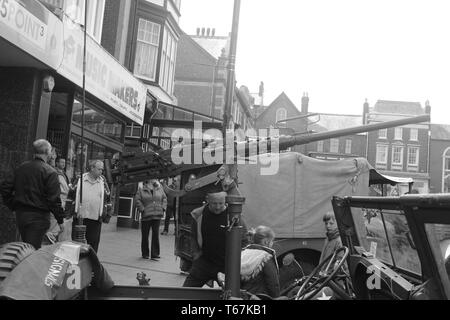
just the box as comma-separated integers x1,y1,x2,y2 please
135,180,167,260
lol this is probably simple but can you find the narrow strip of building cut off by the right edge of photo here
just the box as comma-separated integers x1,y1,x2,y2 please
430,124,450,193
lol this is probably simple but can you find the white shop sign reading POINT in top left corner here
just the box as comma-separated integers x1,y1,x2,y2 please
0,0,63,69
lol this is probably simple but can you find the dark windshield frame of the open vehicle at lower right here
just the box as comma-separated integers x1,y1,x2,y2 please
333,194,450,299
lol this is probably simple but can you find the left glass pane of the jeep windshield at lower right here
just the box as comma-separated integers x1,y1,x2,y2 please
353,208,421,275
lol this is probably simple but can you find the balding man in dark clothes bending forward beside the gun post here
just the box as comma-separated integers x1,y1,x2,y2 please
183,192,248,288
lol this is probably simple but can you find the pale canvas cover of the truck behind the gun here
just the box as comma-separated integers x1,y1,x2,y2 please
238,152,370,238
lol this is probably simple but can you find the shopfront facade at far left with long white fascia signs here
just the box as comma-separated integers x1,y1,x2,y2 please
0,0,152,242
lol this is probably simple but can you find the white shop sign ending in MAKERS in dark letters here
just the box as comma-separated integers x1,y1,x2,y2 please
57,16,147,125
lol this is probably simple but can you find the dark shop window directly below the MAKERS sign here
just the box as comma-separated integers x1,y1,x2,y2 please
72,99,123,142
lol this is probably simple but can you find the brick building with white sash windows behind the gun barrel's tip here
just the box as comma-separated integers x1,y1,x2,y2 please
364,100,431,194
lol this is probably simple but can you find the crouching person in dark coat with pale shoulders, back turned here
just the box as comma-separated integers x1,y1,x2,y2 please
241,226,280,298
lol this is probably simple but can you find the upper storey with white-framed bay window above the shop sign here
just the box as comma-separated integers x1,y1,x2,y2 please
101,0,181,105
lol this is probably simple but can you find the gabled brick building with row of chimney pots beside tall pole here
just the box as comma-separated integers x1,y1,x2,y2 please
175,28,254,130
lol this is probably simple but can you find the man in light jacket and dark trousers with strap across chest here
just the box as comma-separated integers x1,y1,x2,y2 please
74,160,108,252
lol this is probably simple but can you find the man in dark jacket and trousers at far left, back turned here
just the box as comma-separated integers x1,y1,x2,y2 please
0,140,64,249
